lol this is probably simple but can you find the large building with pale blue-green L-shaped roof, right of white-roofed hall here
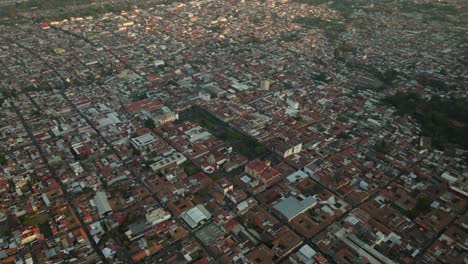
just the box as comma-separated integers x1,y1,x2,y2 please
273,196,317,222
